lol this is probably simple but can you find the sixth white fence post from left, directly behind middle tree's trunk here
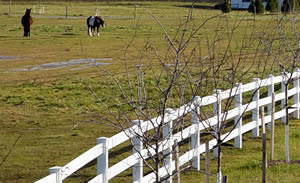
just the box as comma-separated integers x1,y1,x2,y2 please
213,89,222,158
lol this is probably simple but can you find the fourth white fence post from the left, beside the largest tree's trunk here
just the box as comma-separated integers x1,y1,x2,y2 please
163,109,173,183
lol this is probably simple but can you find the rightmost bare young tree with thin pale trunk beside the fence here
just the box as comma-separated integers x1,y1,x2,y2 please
264,15,300,162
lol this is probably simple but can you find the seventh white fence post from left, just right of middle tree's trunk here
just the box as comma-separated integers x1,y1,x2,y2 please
234,83,243,148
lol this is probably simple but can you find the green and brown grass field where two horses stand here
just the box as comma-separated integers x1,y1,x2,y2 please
0,1,300,183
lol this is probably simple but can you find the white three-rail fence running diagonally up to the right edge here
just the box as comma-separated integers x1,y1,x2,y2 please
36,70,300,183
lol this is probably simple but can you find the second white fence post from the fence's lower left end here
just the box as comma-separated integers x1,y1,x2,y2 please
97,137,108,183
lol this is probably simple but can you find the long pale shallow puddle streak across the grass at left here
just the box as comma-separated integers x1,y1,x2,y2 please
1,58,112,73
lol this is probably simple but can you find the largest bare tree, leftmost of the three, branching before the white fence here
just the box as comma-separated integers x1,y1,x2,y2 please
89,5,223,182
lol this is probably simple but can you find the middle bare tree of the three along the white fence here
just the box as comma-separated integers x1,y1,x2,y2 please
192,12,271,182
